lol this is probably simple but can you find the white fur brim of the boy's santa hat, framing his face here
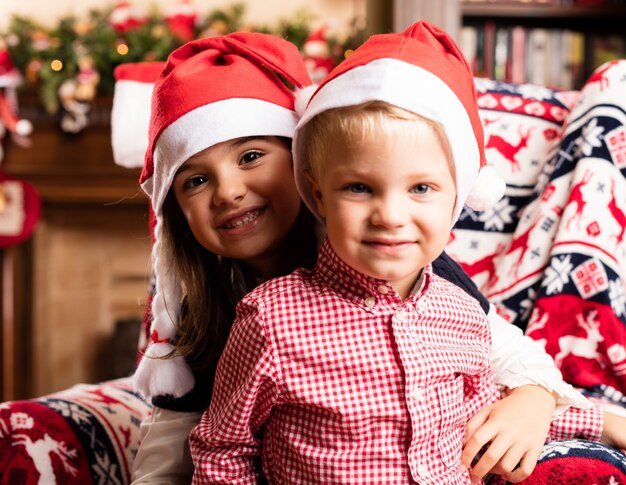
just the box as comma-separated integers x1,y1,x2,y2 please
293,58,480,220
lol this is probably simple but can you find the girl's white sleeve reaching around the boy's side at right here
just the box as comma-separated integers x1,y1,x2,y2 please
488,305,592,415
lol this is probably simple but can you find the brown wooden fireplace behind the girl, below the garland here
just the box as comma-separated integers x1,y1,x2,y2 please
0,96,151,401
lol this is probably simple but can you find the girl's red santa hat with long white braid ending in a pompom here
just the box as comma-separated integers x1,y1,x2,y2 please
134,32,310,396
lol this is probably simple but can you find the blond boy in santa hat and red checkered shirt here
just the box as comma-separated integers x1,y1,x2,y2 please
190,22,608,485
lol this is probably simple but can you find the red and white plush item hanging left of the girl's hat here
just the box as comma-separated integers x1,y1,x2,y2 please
111,61,165,168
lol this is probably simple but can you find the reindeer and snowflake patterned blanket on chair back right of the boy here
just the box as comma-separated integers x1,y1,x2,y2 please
448,61,626,392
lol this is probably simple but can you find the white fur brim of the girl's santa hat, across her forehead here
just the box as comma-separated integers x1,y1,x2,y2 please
141,98,298,213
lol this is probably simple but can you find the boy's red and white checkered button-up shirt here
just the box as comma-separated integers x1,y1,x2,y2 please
191,242,601,485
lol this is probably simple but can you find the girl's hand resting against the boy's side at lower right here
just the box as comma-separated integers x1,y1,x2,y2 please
461,385,556,482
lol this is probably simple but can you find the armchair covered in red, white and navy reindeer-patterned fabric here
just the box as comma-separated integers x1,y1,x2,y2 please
0,61,626,485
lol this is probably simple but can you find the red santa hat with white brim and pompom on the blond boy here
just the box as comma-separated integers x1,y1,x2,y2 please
293,21,505,220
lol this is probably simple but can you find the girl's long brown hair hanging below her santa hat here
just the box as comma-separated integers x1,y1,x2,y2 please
161,183,317,375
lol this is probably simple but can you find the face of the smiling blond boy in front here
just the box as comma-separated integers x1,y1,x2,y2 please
312,121,456,298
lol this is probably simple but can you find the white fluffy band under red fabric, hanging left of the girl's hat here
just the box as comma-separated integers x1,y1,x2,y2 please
111,80,154,168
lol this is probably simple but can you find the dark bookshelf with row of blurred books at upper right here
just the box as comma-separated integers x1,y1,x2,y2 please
459,0,626,89
